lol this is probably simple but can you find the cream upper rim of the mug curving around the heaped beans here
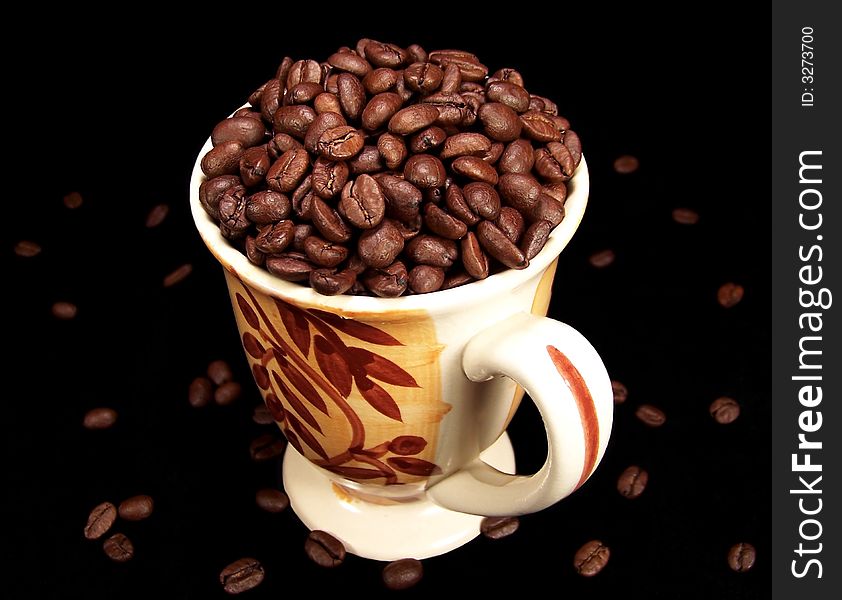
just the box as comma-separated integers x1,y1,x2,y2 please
190,137,590,314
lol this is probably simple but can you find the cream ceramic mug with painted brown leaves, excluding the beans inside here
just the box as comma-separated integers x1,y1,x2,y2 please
190,141,613,560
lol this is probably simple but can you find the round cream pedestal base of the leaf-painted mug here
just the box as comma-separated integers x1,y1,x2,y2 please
283,432,515,561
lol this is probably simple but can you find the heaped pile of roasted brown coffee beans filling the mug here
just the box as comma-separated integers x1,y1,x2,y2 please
199,39,582,297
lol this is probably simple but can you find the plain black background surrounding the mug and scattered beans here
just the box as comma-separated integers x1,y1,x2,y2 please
2,14,771,598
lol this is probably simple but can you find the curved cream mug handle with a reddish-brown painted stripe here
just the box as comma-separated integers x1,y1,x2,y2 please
427,312,614,516
